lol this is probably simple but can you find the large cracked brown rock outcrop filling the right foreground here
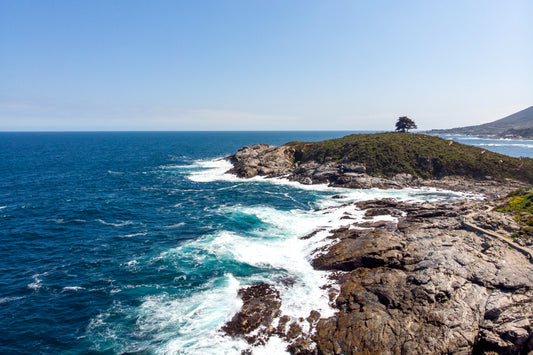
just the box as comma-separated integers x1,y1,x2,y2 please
313,201,533,354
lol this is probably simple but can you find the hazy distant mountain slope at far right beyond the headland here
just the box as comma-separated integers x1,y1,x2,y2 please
428,106,533,138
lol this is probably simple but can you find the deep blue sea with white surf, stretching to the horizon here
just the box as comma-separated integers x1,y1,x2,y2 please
0,132,533,354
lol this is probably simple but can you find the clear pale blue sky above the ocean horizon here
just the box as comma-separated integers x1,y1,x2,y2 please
0,0,533,131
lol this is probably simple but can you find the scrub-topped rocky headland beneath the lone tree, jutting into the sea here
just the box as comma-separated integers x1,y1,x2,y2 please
225,133,533,196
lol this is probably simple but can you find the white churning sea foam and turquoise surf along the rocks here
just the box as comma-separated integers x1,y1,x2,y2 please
90,160,474,354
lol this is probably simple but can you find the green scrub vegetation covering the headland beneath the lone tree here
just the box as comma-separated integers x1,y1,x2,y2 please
286,132,533,183
